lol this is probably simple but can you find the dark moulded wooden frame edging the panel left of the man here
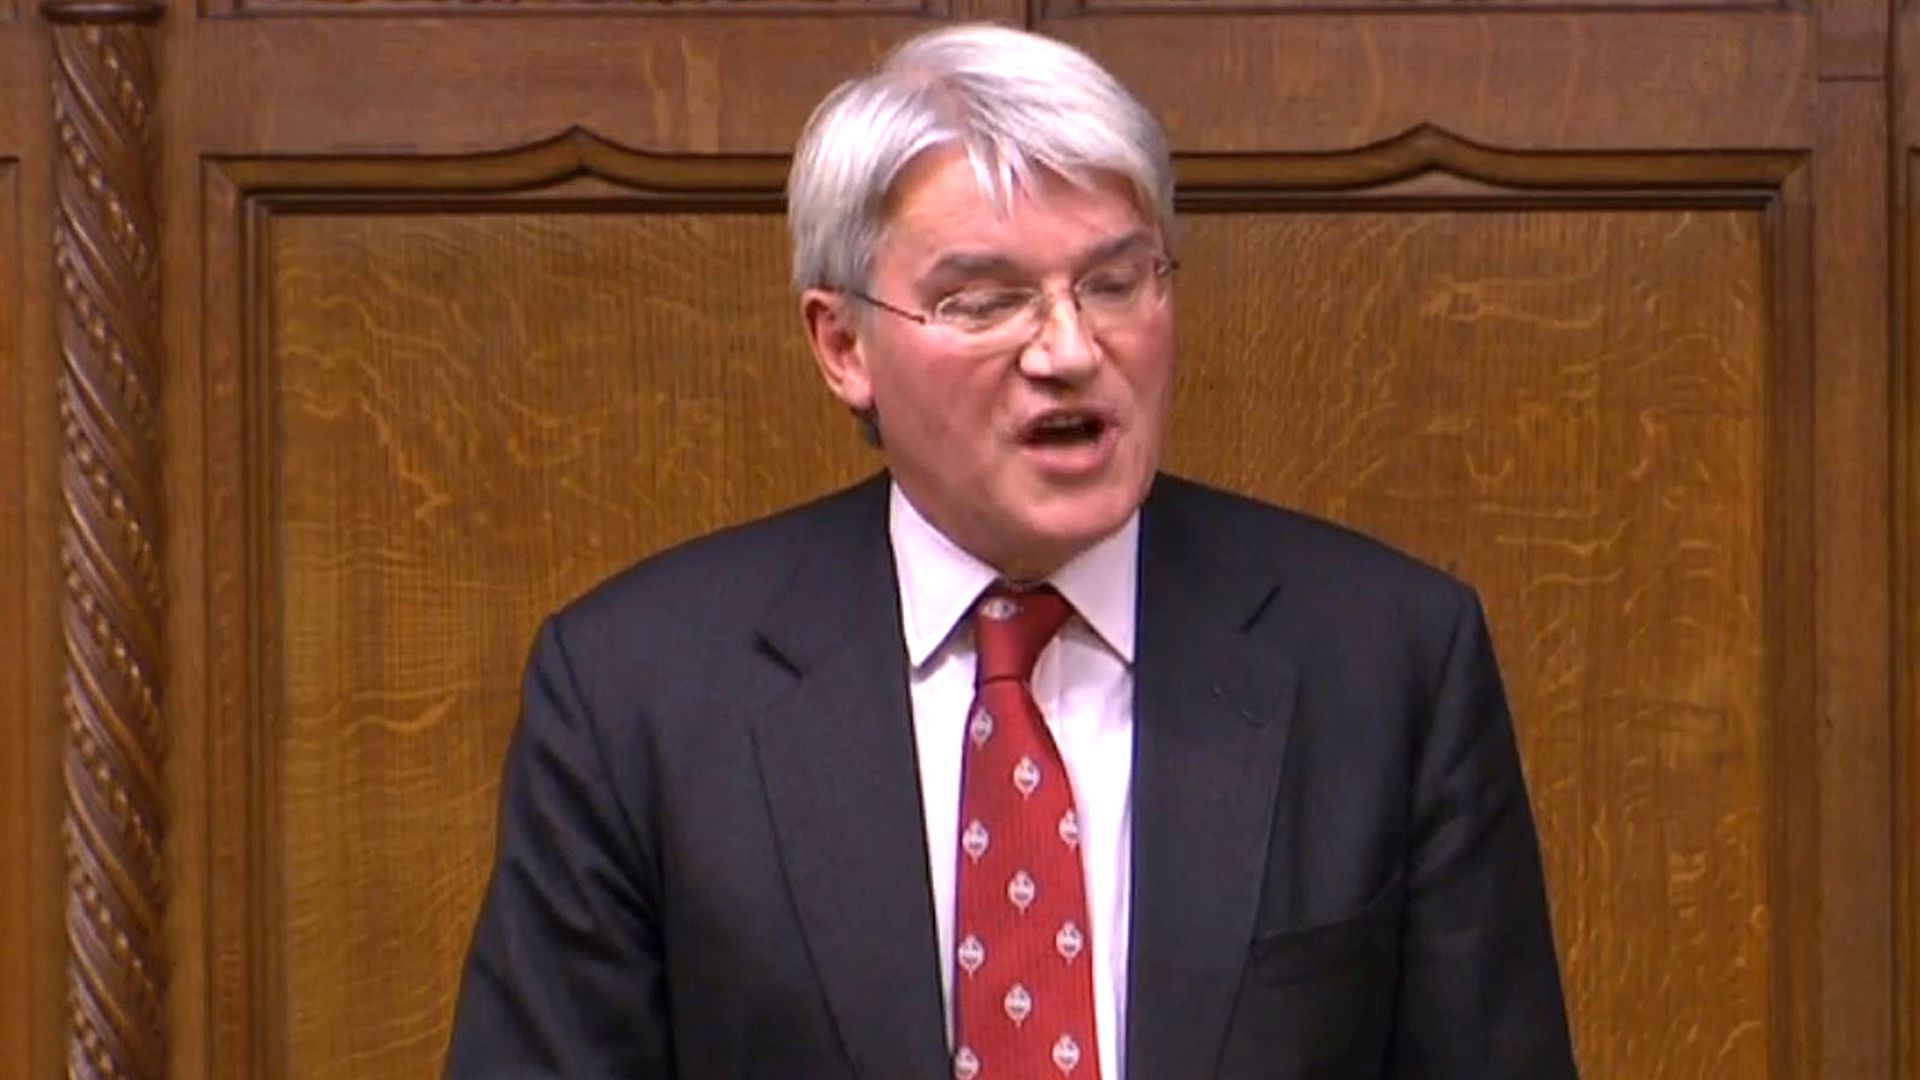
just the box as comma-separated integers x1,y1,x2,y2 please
202,131,787,1080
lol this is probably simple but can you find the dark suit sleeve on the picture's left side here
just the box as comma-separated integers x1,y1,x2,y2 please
445,621,672,1080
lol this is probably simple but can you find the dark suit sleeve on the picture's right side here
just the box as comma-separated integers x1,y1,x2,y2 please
1390,592,1576,1080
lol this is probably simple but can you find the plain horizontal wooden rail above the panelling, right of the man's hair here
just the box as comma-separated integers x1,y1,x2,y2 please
1039,4,1814,152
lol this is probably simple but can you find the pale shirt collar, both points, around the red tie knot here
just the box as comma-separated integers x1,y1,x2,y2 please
887,482,1140,669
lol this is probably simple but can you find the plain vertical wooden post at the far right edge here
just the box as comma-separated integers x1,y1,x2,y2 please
1812,77,1901,1076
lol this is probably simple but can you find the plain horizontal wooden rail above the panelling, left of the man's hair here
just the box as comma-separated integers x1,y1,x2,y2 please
175,17,1020,156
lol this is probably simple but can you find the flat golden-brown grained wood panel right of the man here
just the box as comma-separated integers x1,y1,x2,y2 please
1173,208,1774,1078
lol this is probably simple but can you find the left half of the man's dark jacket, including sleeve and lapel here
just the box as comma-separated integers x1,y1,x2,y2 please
447,470,947,1080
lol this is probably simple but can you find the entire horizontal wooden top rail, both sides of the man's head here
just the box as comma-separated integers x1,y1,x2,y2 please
179,13,1814,154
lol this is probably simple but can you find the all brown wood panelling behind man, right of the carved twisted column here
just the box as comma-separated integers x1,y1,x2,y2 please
86,8,1873,1080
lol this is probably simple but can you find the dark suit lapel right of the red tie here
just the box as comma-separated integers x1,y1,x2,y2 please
1127,480,1296,1080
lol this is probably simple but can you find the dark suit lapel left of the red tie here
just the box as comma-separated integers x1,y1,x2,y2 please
753,482,948,1080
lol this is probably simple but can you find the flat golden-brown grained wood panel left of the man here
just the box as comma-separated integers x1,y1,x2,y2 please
252,203,874,1078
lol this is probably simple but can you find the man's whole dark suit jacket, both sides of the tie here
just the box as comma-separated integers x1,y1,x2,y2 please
447,477,1574,1080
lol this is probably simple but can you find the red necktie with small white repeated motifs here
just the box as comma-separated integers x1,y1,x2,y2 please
954,586,1100,1080
